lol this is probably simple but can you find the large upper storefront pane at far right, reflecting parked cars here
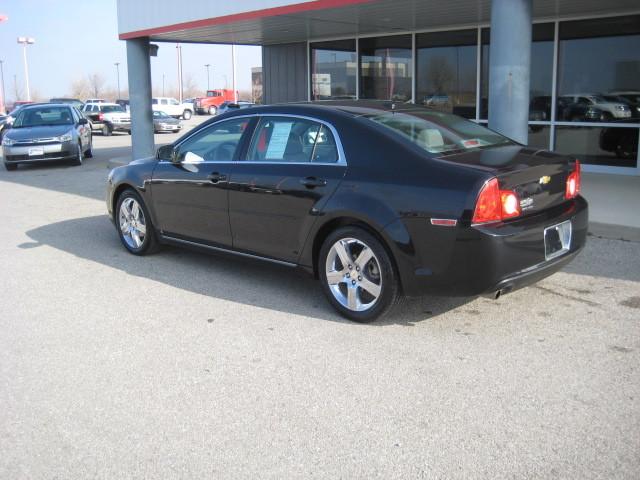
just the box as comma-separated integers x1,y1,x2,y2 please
557,15,640,123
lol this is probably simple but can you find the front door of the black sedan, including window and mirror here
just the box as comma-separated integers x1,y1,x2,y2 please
151,117,251,247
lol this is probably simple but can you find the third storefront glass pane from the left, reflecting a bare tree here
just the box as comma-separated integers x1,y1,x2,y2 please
416,29,478,118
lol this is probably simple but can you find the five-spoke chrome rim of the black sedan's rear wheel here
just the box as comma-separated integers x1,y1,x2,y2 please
325,238,382,312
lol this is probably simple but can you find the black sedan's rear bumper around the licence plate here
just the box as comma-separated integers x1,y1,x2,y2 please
388,197,588,296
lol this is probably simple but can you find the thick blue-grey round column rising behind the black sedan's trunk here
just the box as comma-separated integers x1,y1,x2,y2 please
489,0,532,145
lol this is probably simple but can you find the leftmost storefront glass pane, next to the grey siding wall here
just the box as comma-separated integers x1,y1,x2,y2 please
311,40,358,100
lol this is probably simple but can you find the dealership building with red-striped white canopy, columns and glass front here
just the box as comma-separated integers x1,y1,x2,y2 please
118,0,640,176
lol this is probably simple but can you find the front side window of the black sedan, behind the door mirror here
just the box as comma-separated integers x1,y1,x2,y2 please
178,118,250,163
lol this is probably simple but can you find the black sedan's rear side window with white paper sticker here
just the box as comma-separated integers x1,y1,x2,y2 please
247,117,339,163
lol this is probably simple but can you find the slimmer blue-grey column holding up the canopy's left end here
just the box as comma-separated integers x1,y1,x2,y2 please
127,38,156,159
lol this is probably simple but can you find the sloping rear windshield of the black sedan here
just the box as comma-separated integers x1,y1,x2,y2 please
364,110,513,153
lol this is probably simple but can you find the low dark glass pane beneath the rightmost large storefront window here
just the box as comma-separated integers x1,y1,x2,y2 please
555,126,638,168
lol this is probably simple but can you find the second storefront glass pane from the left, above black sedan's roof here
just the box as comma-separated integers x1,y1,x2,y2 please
359,35,412,102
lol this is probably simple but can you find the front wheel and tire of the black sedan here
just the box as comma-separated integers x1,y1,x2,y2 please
113,189,158,255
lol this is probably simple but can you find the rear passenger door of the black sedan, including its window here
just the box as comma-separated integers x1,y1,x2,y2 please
229,115,346,262
